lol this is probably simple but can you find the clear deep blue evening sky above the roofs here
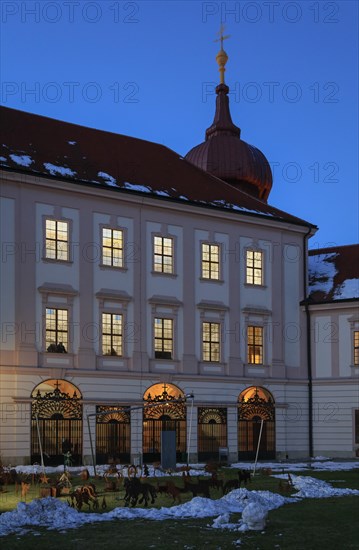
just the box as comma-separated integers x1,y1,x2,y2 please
0,0,359,248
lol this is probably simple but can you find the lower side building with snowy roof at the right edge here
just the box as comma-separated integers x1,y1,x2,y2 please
305,245,359,457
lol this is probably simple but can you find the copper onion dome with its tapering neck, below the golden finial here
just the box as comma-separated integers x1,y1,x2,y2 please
185,83,272,201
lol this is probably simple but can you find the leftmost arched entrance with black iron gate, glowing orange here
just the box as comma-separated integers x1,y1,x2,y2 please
31,380,82,466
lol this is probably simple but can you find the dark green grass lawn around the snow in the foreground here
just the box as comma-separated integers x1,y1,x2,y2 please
0,469,359,550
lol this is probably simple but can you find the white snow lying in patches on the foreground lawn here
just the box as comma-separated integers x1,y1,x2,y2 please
0,457,359,545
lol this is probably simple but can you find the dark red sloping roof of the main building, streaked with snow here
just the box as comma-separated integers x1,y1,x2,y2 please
0,107,315,228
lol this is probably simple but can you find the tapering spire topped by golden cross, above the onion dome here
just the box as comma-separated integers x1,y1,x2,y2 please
206,25,241,140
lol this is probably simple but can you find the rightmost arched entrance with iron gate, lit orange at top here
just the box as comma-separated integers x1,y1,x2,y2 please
238,386,275,460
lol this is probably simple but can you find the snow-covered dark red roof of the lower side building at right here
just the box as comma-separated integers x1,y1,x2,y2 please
308,245,359,302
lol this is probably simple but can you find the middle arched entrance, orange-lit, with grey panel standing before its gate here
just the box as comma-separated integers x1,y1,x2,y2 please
143,383,186,462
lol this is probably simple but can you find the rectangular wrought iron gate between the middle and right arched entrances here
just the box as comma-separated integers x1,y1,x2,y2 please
198,407,227,460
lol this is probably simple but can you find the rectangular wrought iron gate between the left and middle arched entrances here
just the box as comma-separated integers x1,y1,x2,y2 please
96,405,131,464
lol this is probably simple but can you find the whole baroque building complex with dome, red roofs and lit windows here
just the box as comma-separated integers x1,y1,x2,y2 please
0,41,359,464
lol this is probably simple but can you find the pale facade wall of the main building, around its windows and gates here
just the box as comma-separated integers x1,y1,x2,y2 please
0,167,320,463
